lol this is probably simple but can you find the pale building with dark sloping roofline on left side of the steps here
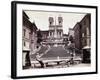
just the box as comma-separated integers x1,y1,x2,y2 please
22,12,37,68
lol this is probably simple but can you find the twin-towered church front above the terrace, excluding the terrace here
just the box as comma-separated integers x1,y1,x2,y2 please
49,17,63,39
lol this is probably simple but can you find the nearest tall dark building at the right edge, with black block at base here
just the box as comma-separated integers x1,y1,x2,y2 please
80,14,91,63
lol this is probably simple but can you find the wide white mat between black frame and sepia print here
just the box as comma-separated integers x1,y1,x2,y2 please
11,1,96,77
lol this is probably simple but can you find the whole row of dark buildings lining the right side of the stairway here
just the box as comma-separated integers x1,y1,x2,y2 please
73,14,91,63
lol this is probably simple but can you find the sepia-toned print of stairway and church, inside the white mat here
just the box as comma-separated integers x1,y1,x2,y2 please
22,10,91,69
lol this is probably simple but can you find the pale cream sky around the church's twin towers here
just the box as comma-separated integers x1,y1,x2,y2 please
25,10,86,34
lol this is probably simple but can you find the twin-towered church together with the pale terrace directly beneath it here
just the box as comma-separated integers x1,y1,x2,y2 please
42,16,68,46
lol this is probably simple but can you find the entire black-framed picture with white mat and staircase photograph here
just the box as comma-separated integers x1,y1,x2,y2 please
12,1,97,78
